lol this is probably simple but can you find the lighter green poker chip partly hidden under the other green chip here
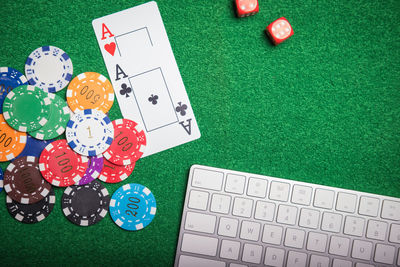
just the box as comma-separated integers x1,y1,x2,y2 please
29,93,70,140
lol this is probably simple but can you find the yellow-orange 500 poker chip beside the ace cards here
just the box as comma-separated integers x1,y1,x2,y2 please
67,72,114,113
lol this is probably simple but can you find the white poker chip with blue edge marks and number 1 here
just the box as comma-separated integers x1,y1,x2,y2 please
65,109,114,157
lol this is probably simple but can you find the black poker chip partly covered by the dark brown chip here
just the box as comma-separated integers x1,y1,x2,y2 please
6,188,56,224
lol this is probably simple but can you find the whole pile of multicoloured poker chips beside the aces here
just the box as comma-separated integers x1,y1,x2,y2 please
0,46,156,230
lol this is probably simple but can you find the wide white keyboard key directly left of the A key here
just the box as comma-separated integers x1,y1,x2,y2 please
181,233,218,256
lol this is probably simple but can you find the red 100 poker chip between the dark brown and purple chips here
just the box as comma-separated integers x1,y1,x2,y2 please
39,139,88,187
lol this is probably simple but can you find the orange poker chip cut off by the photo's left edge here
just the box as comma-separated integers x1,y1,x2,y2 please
0,114,26,161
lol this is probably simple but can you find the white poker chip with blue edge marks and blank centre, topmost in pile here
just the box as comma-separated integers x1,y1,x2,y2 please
25,46,73,93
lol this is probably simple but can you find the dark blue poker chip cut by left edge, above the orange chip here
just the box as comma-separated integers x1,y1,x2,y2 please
0,67,28,114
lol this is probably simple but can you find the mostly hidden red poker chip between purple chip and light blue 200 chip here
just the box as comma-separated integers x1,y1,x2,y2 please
98,159,135,184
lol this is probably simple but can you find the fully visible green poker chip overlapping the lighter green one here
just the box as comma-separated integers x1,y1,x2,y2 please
3,85,51,132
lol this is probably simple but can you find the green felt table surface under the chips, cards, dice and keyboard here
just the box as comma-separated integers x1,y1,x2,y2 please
0,0,400,266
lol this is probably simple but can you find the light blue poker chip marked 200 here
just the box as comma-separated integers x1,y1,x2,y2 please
110,184,157,231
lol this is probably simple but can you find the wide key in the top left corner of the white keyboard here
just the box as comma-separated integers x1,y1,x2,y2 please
192,168,224,191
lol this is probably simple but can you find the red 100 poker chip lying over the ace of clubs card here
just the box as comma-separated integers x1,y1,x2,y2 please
103,119,146,165
